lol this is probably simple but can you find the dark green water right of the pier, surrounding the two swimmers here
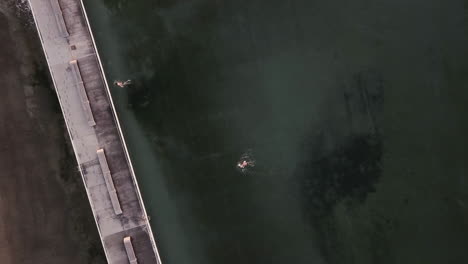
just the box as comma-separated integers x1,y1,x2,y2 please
85,0,468,264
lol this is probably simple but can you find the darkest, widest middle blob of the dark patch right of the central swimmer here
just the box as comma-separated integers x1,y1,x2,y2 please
296,135,382,218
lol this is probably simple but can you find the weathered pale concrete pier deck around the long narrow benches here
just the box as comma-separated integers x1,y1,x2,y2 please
30,0,160,263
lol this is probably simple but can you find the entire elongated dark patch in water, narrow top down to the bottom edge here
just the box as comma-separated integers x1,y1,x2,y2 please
294,70,388,263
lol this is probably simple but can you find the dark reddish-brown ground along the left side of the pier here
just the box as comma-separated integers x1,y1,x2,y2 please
0,0,105,264
